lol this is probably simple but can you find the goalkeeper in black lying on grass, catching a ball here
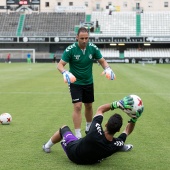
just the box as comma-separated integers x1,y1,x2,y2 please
43,96,143,164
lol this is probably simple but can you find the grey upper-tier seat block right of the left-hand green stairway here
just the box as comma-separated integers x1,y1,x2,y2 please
22,12,85,36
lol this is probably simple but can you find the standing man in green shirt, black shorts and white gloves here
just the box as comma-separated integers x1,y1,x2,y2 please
57,27,116,138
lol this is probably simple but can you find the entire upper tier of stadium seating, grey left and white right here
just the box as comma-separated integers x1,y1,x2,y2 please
0,11,170,36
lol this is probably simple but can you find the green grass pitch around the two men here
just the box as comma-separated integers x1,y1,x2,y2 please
0,63,170,170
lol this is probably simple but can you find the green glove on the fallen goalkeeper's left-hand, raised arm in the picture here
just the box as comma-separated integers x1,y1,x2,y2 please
111,96,134,110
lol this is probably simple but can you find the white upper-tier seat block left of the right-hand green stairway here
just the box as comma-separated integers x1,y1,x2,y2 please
91,12,136,36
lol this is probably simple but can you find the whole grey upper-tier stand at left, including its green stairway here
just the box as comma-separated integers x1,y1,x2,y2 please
0,12,85,36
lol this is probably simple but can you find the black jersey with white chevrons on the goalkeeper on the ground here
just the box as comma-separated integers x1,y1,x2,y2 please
66,115,127,164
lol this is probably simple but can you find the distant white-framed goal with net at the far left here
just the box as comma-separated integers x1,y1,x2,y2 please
0,49,35,63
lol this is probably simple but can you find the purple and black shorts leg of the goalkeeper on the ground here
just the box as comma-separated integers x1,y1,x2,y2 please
60,126,78,154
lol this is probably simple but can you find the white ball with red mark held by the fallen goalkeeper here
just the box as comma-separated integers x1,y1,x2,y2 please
126,94,144,118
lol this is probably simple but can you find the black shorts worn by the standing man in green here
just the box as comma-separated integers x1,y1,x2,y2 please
70,83,94,103
